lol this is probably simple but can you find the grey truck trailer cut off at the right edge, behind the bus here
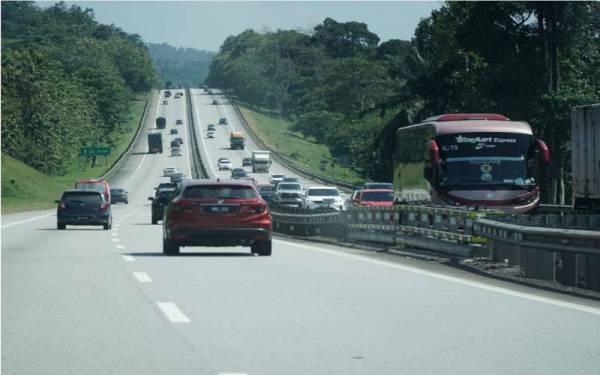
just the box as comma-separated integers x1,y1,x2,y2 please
571,103,600,212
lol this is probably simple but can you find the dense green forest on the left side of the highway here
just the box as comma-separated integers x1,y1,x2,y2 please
2,1,157,174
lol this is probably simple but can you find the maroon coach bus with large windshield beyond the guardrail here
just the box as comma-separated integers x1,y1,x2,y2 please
394,113,550,213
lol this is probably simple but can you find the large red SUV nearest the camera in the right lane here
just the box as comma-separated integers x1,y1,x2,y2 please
163,179,273,256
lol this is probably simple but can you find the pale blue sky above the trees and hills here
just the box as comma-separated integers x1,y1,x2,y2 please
48,1,442,51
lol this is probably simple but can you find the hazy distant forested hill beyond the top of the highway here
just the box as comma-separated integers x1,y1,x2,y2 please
147,43,214,87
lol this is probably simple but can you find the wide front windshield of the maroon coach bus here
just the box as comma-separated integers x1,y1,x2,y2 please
436,133,535,188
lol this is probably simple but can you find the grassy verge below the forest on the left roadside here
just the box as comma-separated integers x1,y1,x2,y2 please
1,94,148,214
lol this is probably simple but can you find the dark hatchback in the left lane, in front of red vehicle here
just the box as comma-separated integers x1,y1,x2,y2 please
55,189,112,230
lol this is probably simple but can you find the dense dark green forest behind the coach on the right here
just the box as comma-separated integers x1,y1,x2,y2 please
207,2,600,201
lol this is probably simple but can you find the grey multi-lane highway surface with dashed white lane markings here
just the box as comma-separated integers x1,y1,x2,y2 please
1,90,600,375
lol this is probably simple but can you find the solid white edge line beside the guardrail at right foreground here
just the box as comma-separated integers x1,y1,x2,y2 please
274,239,600,315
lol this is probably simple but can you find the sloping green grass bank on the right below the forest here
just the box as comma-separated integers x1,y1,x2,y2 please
240,105,363,184
